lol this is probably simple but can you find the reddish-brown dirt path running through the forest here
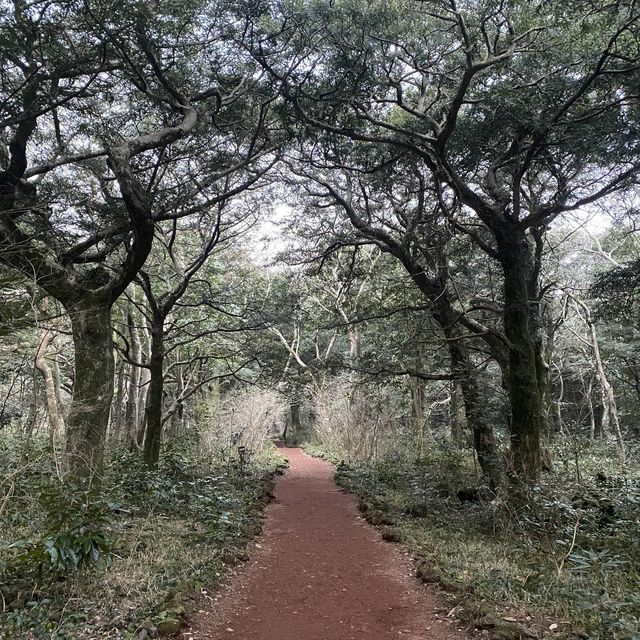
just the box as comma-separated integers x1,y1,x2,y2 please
183,449,464,640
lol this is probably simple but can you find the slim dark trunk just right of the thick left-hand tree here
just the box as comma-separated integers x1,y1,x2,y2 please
143,316,164,469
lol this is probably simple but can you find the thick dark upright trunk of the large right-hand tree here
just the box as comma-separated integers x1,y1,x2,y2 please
498,224,544,481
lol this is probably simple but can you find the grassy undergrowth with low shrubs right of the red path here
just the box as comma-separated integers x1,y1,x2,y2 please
320,445,640,640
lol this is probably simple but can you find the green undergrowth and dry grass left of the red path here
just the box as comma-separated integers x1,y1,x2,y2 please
0,432,284,640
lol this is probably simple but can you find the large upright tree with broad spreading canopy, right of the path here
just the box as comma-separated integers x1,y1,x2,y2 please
247,0,640,480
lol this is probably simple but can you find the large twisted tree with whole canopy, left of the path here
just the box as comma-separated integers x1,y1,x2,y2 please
0,0,272,478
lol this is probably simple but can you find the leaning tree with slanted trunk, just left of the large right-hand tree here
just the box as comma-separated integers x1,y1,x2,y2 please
282,158,505,489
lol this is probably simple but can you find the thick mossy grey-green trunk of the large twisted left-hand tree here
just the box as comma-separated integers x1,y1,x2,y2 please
65,295,114,482
